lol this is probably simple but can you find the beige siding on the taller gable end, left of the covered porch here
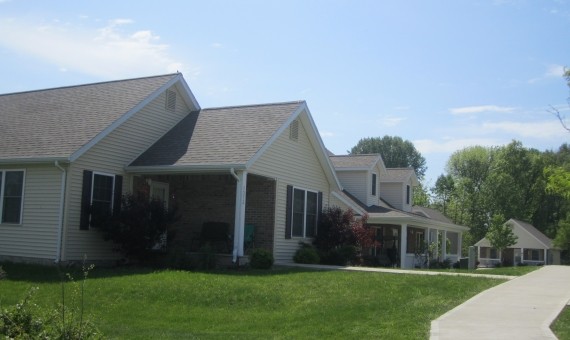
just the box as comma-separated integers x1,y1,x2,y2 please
64,88,190,260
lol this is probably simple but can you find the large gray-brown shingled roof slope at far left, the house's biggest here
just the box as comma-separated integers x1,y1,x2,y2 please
0,74,177,159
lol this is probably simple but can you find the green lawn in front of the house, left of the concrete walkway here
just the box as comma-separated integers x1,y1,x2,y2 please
0,264,503,339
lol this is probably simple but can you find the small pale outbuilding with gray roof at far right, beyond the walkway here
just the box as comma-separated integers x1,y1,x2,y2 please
475,218,560,267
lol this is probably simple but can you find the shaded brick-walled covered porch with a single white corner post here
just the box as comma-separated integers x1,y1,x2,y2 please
132,169,276,263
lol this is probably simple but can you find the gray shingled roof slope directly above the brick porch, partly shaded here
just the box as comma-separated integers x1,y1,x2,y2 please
130,101,304,166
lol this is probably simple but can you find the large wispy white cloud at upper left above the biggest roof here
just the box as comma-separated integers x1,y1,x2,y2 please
0,17,183,79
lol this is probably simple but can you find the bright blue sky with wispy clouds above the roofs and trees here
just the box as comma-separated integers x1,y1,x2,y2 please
0,0,570,186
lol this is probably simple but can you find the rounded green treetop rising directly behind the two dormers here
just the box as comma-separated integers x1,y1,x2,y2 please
349,136,427,180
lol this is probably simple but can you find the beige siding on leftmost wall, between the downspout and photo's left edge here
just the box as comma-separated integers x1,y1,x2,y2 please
0,165,61,260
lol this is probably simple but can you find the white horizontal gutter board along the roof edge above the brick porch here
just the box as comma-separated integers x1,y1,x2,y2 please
124,164,246,175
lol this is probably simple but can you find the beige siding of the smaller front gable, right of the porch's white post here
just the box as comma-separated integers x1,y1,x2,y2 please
250,120,330,262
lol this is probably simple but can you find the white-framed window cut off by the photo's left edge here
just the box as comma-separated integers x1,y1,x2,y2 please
0,170,24,224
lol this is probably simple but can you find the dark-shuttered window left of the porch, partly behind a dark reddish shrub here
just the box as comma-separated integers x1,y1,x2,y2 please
79,170,123,229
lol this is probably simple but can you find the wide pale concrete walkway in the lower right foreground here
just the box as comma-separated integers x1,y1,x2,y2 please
430,266,570,340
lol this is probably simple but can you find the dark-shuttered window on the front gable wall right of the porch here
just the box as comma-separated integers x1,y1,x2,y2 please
285,186,322,238
